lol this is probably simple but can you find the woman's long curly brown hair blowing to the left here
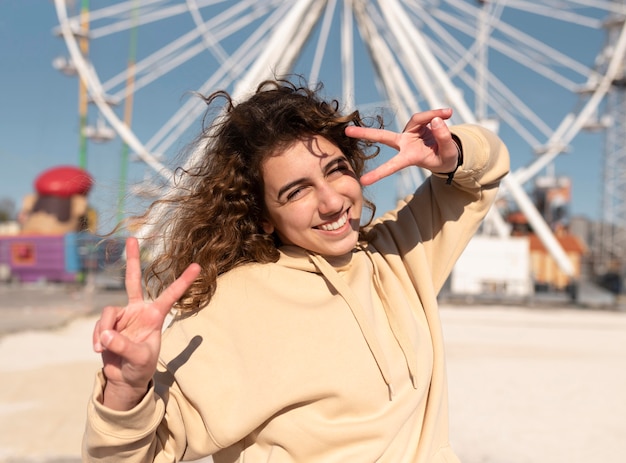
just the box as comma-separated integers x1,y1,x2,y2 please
140,79,382,311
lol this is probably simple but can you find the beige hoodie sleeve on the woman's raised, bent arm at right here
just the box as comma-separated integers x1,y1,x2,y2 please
372,124,509,293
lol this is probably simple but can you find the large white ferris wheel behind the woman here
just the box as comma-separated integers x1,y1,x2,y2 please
55,0,626,280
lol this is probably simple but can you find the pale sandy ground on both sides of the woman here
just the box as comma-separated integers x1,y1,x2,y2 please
0,296,626,463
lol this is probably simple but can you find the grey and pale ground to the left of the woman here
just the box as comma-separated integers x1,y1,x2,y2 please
0,284,125,463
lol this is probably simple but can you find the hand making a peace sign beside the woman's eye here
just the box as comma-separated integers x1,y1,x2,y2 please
346,108,458,185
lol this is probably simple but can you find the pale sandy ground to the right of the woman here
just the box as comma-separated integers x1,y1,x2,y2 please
441,307,626,463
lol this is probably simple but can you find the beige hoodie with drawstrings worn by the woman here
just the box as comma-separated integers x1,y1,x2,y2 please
84,125,509,463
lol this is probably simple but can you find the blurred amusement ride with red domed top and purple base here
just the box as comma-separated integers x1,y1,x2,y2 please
0,166,122,283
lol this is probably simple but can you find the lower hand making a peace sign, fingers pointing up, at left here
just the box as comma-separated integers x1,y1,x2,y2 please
93,238,200,410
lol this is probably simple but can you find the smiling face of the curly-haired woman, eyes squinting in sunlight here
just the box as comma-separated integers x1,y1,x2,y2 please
262,136,363,256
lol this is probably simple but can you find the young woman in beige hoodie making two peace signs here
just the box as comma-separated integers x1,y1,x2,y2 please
84,81,508,463
